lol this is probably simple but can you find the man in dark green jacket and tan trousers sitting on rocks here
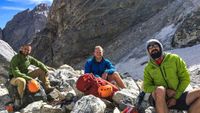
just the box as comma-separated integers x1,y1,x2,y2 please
9,45,54,99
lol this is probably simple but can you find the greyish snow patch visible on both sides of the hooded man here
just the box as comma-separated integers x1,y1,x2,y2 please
116,44,200,79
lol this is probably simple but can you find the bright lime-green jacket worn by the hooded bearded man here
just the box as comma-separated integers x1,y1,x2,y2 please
144,53,190,99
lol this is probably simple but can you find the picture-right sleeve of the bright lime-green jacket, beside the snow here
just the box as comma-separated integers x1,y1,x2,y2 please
175,56,190,99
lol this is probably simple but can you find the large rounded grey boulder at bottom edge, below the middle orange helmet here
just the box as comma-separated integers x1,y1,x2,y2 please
71,95,106,113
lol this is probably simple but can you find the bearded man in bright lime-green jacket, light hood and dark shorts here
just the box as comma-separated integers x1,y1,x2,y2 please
144,39,200,113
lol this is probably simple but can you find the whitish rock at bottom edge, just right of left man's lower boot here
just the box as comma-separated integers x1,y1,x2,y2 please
20,100,44,113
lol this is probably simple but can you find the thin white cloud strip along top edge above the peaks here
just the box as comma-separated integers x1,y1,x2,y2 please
7,0,53,4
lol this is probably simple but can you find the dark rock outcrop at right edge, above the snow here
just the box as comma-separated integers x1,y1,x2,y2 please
172,9,200,47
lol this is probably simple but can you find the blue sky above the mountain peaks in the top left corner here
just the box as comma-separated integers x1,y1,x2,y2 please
0,0,53,29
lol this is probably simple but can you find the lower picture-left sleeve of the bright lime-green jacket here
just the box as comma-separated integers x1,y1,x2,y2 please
143,69,156,93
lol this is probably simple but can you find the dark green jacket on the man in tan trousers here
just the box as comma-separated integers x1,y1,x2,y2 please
9,53,48,80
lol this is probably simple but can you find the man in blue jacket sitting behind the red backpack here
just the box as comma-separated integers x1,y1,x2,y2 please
85,46,126,88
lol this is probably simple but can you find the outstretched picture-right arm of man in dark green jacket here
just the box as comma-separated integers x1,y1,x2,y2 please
29,56,48,73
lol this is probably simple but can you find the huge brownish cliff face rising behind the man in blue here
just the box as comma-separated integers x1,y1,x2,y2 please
33,0,173,66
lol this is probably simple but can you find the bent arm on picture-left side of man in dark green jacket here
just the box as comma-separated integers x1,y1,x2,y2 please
10,57,32,80
